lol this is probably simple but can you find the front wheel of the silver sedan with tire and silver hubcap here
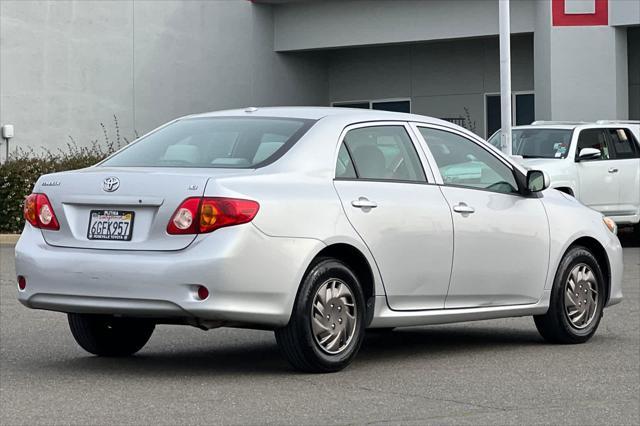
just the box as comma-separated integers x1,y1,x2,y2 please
533,246,605,343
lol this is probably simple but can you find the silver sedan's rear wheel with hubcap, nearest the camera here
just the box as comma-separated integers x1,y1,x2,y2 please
275,259,365,373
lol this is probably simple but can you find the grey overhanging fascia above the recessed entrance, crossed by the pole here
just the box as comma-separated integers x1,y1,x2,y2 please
275,0,537,51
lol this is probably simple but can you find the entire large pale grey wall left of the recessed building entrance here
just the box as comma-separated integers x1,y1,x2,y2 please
0,0,328,158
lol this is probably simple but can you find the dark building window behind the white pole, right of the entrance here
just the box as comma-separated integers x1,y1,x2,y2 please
485,92,536,137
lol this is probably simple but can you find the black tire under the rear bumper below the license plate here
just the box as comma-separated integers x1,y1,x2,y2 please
67,314,155,357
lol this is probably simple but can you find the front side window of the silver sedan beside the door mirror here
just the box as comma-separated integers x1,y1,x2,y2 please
419,127,518,194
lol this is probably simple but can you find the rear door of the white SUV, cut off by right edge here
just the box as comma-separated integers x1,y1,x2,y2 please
606,127,640,216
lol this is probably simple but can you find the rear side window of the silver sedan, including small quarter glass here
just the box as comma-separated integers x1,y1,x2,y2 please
336,126,426,182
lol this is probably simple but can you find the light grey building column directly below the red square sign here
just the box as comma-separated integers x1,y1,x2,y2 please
534,1,629,121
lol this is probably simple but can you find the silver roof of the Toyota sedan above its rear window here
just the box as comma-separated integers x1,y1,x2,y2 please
183,106,452,126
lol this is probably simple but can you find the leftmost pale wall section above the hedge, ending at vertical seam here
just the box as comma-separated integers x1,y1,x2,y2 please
0,0,134,156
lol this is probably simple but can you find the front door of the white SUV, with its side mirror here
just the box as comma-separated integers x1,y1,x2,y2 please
575,128,620,215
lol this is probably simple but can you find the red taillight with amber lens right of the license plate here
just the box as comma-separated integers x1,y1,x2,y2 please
167,197,260,234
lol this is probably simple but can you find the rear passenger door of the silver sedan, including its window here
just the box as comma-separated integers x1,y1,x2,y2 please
334,122,453,310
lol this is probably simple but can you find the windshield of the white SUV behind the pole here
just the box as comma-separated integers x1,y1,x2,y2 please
487,129,573,158
